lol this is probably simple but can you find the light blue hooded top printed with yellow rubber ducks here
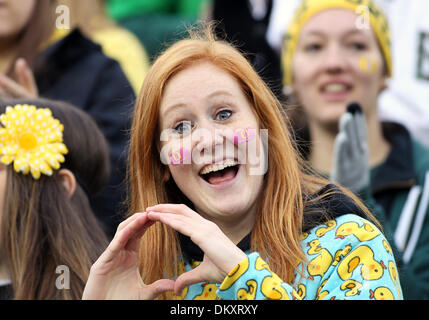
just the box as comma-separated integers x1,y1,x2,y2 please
179,185,402,300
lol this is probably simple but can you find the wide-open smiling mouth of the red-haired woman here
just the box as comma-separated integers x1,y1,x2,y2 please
199,159,240,185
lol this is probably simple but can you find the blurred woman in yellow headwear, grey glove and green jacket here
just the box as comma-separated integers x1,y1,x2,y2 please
282,0,429,299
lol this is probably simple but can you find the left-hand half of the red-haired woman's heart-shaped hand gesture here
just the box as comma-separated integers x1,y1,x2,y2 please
82,212,174,300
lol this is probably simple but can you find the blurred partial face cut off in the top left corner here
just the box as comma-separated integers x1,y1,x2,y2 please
0,0,36,42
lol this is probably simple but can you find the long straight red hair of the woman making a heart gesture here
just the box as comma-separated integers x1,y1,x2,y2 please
127,26,374,298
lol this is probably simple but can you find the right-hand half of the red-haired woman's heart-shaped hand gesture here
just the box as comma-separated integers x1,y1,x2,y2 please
146,204,246,295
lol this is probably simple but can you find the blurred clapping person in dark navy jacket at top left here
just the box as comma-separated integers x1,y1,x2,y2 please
0,0,134,236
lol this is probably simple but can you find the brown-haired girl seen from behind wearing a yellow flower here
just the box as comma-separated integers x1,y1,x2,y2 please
0,99,109,299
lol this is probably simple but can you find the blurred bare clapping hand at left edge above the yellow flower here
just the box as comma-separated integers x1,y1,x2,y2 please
0,58,39,99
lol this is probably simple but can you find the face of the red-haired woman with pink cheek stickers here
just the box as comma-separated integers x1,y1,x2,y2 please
160,62,266,227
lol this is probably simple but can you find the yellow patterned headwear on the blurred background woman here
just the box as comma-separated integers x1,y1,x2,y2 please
282,0,392,86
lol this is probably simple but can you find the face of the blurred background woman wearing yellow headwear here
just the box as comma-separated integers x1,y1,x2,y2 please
292,9,385,129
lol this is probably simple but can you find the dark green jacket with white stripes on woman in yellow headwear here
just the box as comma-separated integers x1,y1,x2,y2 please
363,123,429,299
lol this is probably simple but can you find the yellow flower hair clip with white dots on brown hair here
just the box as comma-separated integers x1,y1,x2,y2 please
0,104,68,180
